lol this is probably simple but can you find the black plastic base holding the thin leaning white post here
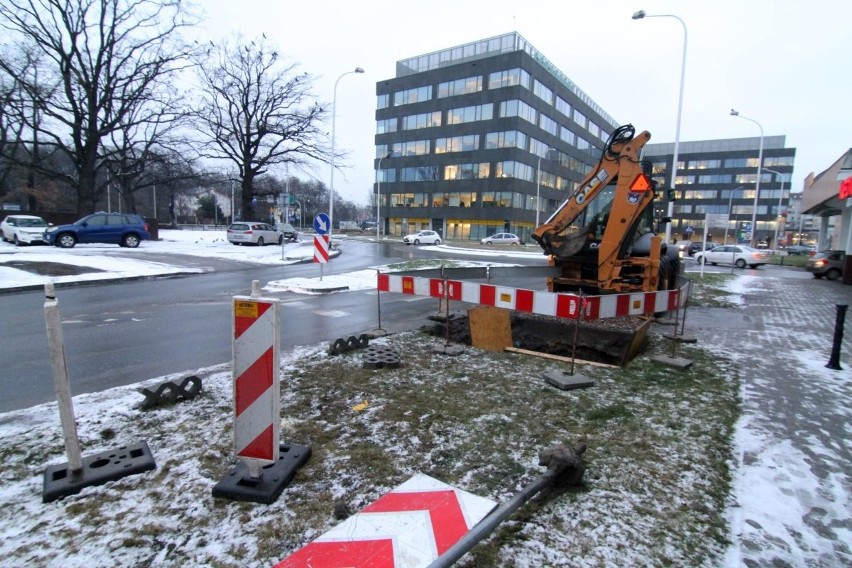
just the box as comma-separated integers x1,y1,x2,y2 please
41,442,157,503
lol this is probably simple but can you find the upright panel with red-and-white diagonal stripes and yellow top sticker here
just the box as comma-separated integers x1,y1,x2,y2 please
232,296,281,477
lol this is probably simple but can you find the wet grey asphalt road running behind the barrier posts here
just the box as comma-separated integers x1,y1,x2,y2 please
0,241,541,412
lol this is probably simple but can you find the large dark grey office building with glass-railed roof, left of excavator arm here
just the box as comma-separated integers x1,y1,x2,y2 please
374,33,618,240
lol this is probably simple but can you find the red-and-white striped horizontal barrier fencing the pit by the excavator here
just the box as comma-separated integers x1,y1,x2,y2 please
377,273,686,320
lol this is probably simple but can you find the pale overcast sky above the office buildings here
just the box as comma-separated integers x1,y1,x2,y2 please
198,0,852,204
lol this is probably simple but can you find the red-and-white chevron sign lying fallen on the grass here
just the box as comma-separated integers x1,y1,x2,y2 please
275,474,496,568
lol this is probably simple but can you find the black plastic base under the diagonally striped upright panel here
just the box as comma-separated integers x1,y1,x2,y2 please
213,444,311,505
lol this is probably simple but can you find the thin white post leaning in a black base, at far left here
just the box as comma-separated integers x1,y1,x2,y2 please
44,282,83,472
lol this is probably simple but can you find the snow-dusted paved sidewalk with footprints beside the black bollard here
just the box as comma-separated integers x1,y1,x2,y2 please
685,268,852,567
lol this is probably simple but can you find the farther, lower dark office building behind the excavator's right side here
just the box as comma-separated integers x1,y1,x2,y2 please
642,136,798,248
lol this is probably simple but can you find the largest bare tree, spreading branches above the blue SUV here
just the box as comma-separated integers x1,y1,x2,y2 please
0,0,192,214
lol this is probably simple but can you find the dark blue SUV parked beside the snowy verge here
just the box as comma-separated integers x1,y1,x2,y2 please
44,211,151,248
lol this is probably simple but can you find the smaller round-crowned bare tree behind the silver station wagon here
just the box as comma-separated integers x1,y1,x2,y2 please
195,33,329,218
